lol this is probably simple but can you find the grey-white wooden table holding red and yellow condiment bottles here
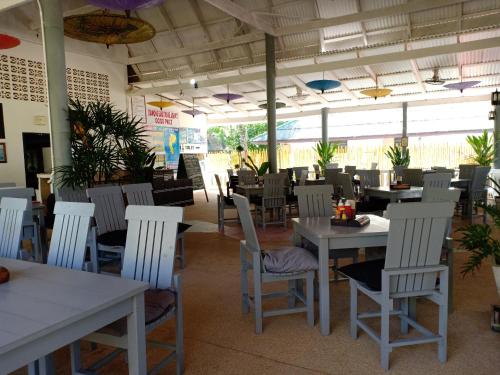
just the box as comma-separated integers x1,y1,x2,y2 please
292,215,389,336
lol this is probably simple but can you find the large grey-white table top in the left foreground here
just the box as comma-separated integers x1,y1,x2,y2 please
0,258,149,356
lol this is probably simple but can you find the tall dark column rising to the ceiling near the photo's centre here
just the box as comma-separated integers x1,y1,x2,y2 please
266,34,278,173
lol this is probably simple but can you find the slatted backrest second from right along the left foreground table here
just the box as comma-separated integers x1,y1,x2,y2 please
47,202,95,270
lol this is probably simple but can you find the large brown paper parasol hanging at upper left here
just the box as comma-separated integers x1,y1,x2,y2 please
64,14,156,46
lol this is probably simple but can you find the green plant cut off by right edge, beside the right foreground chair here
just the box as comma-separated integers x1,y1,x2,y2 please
458,203,500,295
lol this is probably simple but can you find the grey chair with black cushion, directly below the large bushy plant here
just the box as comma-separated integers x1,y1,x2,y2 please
87,186,127,267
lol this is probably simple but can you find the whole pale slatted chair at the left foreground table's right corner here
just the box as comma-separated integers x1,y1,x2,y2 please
77,205,184,375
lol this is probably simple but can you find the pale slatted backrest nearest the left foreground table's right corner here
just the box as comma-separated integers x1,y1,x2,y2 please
121,205,183,289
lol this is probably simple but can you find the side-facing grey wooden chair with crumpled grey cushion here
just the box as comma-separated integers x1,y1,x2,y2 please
233,194,318,334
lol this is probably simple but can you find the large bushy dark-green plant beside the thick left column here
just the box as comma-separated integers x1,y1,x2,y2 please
54,100,150,187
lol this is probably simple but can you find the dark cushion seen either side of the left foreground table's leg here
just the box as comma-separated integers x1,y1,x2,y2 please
98,289,175,337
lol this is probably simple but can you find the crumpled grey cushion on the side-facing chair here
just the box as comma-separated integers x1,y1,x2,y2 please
263,247,318,273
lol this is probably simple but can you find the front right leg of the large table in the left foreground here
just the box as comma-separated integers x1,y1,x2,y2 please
127,293,147,375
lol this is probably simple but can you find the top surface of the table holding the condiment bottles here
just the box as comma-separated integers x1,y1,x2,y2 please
292,215,389,238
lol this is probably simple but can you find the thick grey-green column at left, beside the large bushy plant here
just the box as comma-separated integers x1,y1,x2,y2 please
37,0,72,197
